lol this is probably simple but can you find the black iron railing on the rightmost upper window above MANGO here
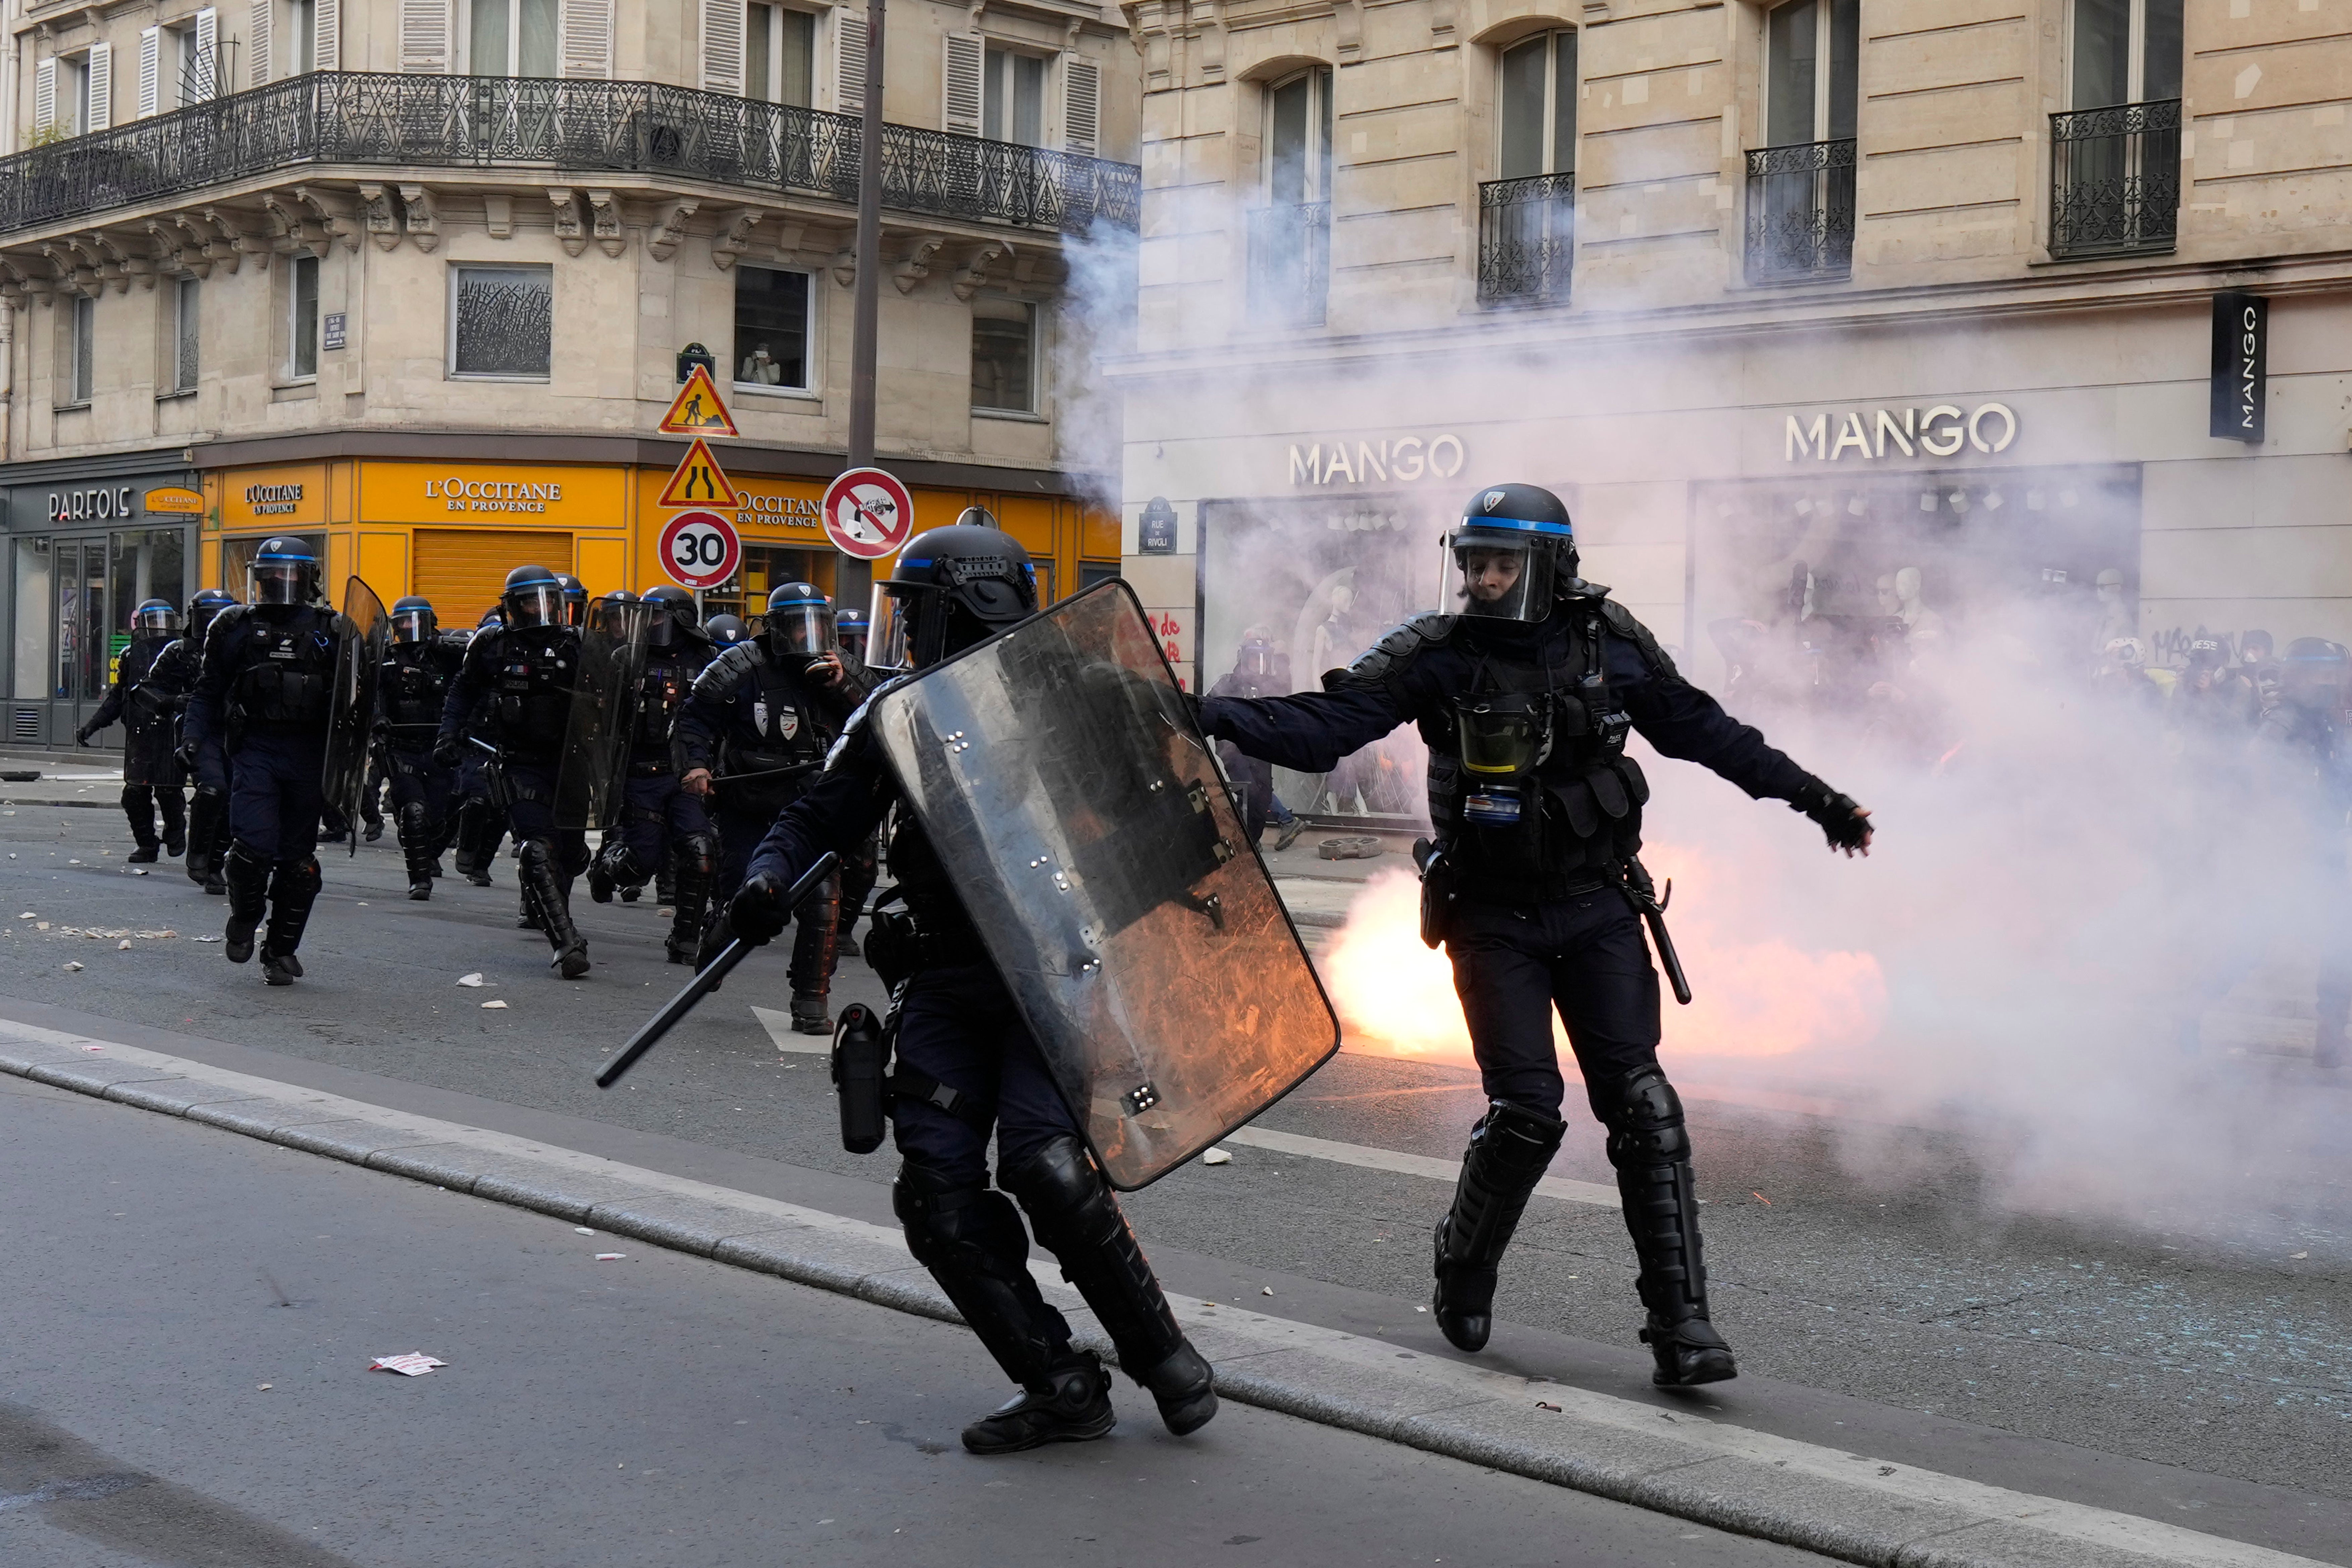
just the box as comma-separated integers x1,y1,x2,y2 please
2051,99,2180,258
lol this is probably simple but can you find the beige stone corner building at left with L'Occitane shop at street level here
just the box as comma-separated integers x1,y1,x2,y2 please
0,0,1138,743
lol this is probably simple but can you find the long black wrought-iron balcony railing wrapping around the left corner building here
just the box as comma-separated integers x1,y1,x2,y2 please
0,70,1141,235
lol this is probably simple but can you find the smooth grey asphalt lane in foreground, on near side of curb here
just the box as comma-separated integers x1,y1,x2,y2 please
0,1079,1820,1568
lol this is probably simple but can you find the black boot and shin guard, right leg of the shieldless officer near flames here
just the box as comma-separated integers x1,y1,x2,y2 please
1592,1067,1741,1389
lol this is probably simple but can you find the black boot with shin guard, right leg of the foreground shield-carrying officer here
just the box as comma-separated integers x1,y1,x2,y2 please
997,1133,1216,1436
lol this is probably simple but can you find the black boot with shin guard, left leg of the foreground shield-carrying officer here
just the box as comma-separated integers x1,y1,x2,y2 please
891,1161,1117,1455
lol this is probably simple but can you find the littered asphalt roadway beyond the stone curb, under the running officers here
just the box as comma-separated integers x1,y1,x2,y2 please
0,806,2352,1549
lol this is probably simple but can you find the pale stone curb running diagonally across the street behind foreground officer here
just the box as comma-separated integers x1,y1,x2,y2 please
0,1025,2310,1568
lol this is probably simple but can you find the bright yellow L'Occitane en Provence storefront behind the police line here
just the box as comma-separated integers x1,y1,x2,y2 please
200,454,1120,625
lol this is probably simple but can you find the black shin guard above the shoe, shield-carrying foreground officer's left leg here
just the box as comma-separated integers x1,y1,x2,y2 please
891,1159,1070,1394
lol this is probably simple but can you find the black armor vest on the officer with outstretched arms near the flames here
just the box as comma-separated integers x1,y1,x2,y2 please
1421,616,1649,903
